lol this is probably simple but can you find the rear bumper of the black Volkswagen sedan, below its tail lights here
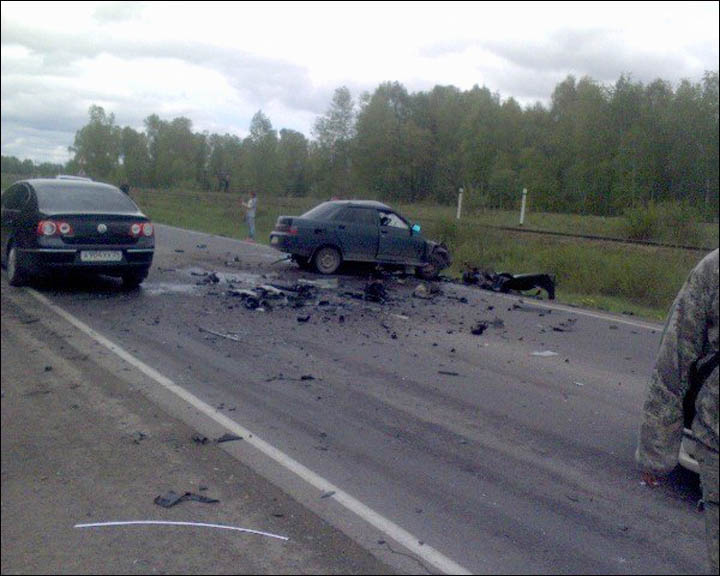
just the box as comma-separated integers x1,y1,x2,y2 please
18,246,155,276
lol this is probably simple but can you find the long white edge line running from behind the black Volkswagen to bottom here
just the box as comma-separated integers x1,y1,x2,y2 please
24,288,472,574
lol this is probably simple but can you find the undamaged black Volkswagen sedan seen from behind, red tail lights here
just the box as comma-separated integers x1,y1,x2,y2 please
2,178,155,288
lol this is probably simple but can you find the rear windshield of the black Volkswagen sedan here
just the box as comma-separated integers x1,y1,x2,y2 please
35,182,138,213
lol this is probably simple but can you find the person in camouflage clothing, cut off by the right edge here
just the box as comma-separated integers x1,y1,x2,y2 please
635,250,719,574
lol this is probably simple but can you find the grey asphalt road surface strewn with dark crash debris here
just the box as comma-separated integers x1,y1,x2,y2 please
3,226,706,574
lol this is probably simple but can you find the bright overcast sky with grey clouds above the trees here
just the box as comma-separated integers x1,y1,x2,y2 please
0,1,719,162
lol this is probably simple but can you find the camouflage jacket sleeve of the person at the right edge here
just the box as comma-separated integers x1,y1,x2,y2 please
635,257,713,474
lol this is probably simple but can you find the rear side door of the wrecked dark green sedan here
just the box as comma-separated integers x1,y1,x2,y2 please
334,206,378,262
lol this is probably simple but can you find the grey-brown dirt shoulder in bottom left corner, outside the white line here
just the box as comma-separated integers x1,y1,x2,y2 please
2,283,391,574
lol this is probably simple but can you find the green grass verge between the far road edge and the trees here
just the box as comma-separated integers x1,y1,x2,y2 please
124,190,717,321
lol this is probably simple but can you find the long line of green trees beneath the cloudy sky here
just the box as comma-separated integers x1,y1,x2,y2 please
2,71,719,219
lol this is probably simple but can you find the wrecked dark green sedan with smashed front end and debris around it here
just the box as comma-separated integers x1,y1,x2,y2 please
270,200,450,279
